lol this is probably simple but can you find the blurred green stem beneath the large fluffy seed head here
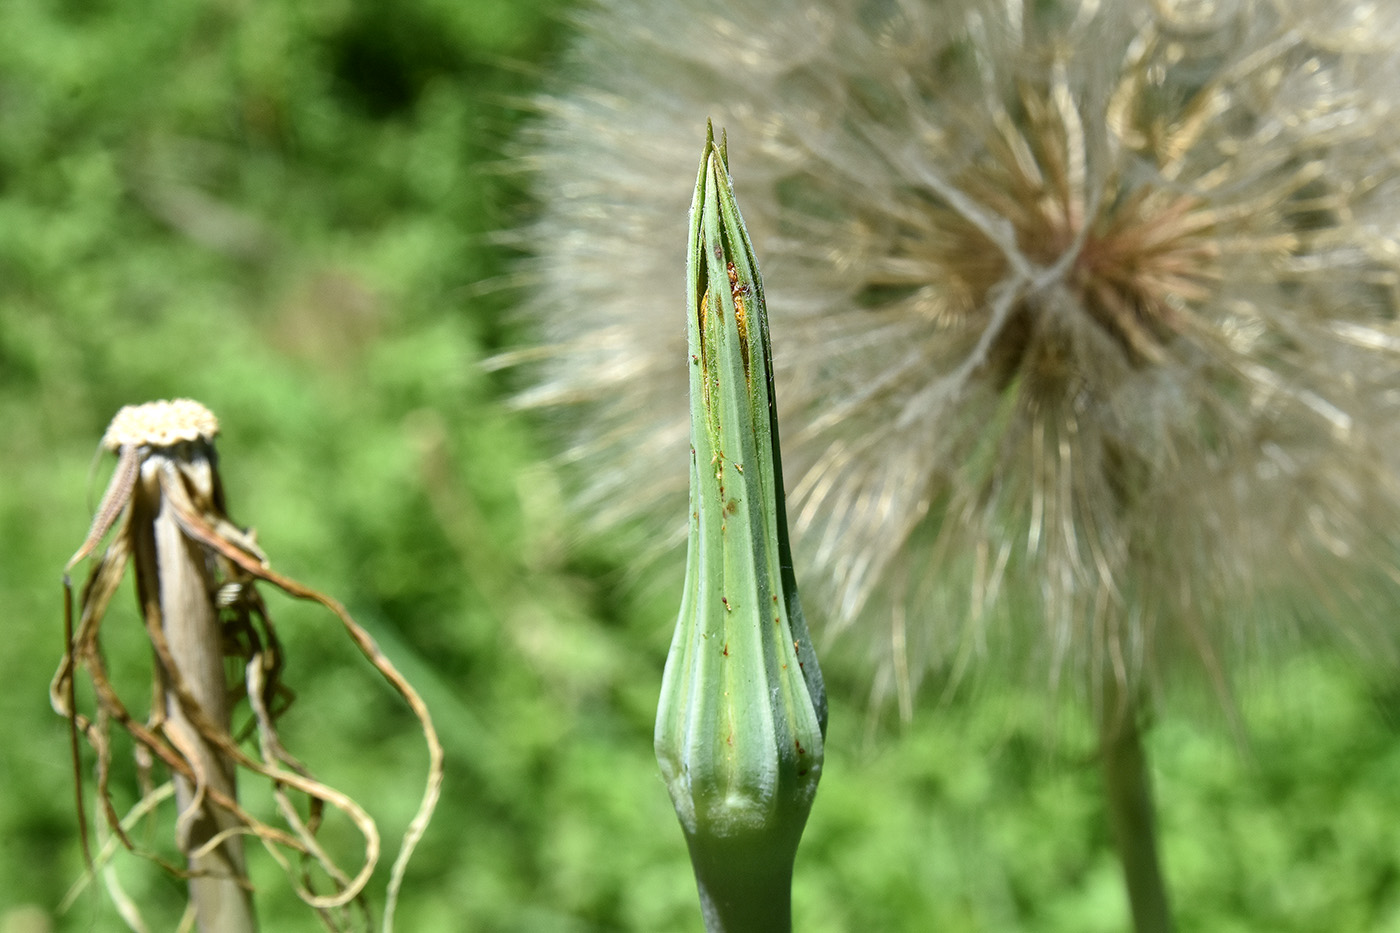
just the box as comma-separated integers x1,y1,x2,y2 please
1099,672,1173,933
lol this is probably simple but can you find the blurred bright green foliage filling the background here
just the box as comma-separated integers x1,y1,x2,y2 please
0,0,1400,933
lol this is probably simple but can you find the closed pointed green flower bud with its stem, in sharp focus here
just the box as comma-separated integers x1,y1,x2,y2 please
657,130,826,933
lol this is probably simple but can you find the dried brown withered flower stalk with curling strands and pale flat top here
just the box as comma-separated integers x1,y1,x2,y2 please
50,399,442,930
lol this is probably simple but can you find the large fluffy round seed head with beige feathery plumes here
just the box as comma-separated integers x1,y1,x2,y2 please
503,0,1400,712
